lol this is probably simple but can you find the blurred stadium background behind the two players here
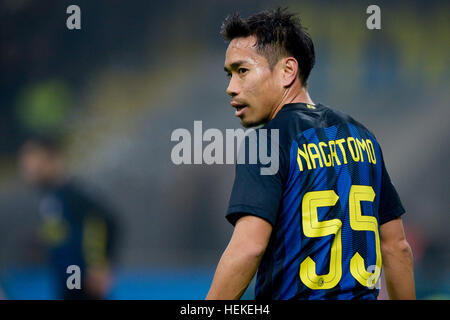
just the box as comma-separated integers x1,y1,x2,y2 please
0,0,450,299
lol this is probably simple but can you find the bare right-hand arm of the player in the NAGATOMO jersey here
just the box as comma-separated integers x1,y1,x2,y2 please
380,218,416,300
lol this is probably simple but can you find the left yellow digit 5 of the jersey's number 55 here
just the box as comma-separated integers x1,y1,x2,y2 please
300,190,342,289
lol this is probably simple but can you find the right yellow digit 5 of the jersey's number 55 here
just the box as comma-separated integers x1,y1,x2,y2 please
349,185,381,287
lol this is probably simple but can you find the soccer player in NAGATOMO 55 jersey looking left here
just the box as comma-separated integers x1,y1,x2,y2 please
207,9,415,300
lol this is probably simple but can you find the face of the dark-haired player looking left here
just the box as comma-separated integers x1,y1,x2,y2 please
225,36,284,127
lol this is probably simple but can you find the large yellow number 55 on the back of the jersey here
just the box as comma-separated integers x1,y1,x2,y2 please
299,185,381,289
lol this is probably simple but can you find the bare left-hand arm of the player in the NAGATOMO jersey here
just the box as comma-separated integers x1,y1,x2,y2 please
206,216,272,300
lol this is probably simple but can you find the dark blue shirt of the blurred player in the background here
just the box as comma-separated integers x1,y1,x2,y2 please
39,182,116,299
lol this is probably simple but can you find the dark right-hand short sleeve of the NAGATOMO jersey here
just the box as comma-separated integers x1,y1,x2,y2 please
379,156,405,225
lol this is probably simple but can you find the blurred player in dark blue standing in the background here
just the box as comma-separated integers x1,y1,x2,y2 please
19,136,116,300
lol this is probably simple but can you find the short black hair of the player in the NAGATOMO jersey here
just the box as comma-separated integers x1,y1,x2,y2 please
220,8,315,86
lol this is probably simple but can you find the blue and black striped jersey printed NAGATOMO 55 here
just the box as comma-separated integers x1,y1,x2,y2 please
227,103,405,299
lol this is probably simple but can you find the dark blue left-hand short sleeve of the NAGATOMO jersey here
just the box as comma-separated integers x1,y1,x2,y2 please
226,129,286,226
